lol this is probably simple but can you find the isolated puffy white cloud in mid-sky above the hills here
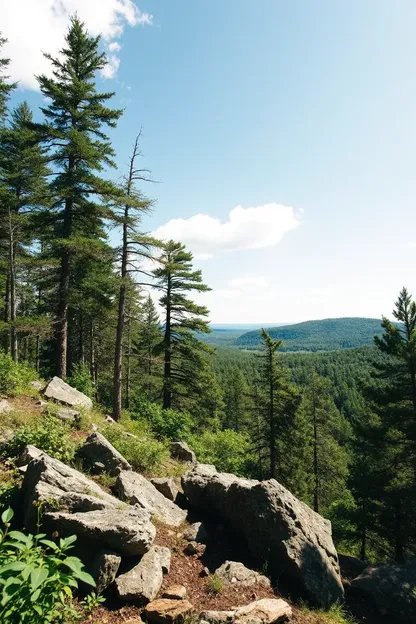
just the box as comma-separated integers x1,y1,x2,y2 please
153,203,301,260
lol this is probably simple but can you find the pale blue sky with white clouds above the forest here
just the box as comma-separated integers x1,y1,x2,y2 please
0,0,416,323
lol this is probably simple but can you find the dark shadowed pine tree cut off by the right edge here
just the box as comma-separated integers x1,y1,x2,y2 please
362,288,416,561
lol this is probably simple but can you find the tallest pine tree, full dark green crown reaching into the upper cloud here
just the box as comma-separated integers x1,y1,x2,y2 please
37,17,122,378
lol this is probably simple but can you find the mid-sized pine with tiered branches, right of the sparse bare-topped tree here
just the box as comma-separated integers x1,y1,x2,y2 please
153,241,210,409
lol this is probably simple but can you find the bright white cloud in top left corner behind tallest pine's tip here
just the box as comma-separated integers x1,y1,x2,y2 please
0,0,152,89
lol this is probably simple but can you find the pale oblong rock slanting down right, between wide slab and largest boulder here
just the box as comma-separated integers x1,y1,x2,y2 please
115,471,187,527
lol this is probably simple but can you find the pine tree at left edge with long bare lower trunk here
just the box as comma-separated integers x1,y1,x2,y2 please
0,102,48,361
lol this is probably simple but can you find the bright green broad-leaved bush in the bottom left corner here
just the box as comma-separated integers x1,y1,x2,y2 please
0,508,95,624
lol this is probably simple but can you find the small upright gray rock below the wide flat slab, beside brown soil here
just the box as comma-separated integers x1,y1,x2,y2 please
116,548,168,605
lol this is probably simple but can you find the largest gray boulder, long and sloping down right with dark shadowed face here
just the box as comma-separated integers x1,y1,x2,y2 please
182,464,344,608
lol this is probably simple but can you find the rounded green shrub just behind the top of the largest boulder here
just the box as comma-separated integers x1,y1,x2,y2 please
189,429,250,475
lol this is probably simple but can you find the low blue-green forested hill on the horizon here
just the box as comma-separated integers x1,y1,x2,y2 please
234,318,382,351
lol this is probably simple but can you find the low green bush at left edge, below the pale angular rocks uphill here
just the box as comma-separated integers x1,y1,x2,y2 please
3,416,75,463
